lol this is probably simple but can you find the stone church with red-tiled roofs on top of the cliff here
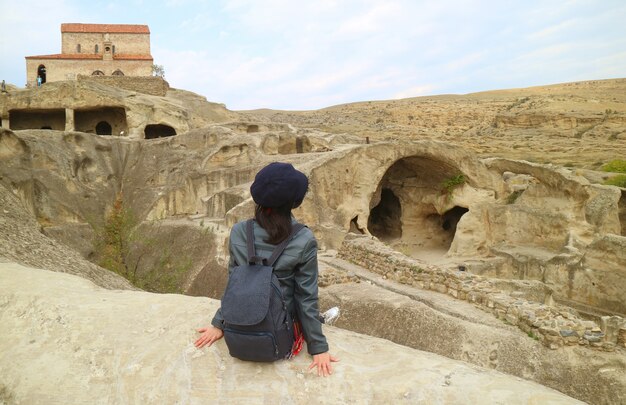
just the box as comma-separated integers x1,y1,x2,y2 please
26,23,153,86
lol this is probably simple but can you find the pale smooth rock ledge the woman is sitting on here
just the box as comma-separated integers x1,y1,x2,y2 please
0,262,578,404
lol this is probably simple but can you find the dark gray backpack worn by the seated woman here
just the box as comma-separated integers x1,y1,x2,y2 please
222,219,304,361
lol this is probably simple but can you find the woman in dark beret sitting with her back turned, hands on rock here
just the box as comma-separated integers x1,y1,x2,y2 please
195,163,338,376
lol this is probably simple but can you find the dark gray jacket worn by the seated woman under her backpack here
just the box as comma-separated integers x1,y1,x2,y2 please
211,220,328,355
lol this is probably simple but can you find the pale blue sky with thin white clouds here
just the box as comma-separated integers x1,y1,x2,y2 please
0,0,626,110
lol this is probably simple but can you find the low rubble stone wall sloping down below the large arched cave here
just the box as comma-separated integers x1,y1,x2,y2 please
338,236,626,351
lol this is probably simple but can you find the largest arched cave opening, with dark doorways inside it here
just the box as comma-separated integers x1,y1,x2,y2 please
367,155,468,259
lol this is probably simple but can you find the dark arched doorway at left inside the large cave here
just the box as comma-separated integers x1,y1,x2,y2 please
367,188,402,241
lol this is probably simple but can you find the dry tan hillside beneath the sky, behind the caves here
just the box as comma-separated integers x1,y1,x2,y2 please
246,79,626,169
